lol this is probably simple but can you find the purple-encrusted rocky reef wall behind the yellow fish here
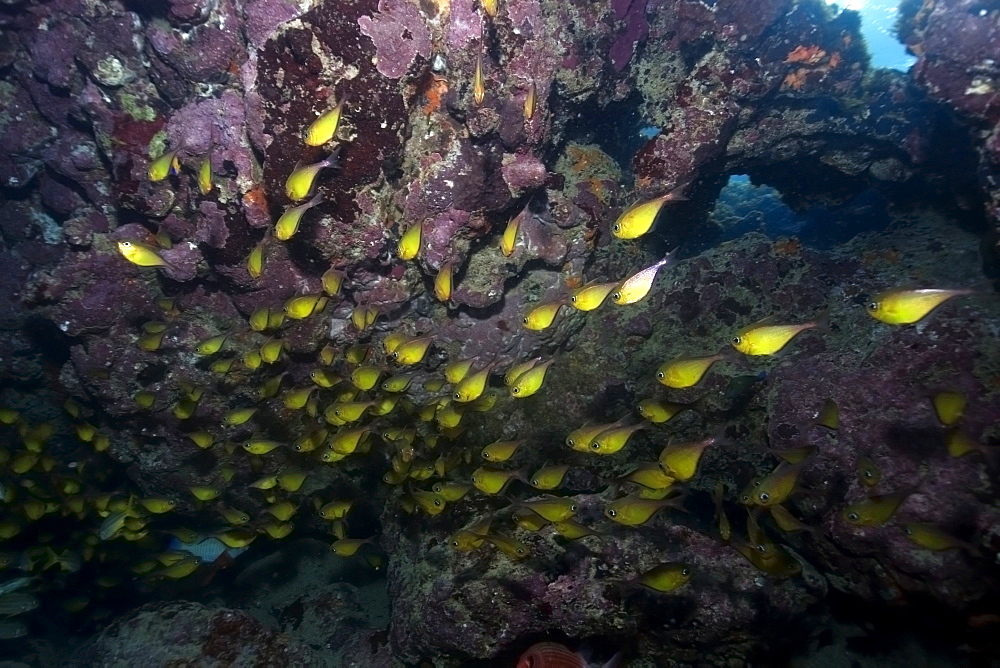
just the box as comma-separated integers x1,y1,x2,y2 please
0,0,1000,666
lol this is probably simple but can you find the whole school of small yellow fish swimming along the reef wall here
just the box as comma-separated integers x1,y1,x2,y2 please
0,3,989,628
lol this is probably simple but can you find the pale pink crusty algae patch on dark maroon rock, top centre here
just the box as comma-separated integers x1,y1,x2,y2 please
358,0,431,79
